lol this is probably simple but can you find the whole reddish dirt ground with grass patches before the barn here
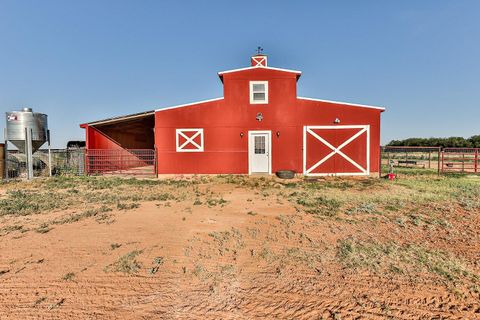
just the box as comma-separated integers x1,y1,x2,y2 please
0,174,480,319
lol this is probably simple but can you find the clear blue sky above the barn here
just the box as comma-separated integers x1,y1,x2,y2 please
0,0,480,147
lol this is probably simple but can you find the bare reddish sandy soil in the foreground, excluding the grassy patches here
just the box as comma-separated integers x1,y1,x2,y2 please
0,176,480,319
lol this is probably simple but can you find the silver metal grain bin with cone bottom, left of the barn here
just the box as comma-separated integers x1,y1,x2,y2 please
6,108,48,153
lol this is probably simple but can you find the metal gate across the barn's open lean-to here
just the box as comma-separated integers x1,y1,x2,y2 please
85,149,156,175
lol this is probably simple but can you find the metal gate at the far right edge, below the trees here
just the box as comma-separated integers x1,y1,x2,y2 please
441,148,480,173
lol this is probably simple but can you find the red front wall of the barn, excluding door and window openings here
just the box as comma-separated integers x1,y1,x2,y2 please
155,68,381,174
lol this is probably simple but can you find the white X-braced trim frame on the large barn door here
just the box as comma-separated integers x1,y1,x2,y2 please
303,125,370,176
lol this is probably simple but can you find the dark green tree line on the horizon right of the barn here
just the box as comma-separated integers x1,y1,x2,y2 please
387,135,480,148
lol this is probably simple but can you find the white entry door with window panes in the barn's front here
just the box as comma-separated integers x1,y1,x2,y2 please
248,131,271,174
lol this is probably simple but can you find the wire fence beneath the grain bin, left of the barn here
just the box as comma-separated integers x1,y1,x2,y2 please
3,149,85,179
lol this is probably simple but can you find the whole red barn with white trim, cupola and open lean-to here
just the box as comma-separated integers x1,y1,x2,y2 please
81,55,385,176
